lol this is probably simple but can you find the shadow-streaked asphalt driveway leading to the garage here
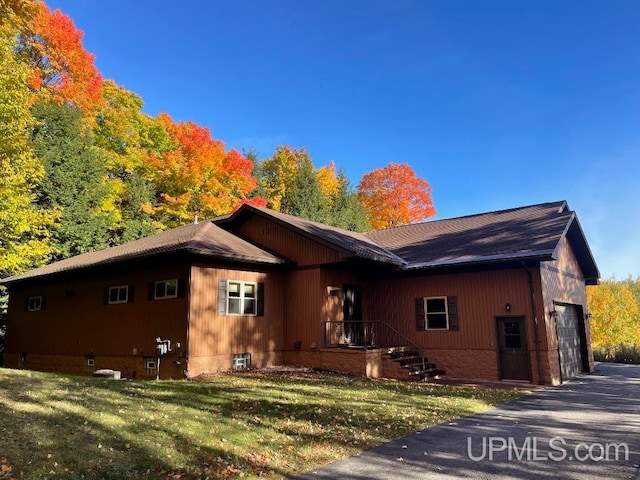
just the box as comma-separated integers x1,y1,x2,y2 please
296,363,640,480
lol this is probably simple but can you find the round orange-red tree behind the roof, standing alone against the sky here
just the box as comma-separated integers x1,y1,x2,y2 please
357,163,436,229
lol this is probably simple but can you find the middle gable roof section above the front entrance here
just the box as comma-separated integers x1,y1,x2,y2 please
213,205,406,266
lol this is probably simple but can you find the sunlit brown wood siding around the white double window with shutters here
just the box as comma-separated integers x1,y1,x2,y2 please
189,265,284,369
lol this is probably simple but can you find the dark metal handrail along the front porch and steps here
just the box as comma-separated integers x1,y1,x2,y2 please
322,320,426,370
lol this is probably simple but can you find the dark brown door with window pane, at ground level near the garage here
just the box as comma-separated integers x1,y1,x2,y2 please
498,317,531,380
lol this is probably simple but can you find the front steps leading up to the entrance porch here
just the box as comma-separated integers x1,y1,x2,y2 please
382,347,445,381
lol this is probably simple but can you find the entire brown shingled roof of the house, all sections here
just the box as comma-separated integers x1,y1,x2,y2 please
0,202,600,284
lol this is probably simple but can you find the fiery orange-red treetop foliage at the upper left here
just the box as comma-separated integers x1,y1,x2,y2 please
24,2,102,115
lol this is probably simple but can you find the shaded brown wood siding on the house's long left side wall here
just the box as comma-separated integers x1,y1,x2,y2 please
6,265,189,357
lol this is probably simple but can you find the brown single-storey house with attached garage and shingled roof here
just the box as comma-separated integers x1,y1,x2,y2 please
3,202,599,384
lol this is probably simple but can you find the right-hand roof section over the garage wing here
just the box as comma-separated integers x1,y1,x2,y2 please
367,201,599,279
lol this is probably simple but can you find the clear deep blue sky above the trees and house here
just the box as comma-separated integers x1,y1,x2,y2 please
47,0,640,279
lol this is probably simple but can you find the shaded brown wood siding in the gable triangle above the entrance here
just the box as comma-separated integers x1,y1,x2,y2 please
237,216,340,266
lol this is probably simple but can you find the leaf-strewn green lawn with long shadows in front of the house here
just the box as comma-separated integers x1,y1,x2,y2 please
0,369,523,480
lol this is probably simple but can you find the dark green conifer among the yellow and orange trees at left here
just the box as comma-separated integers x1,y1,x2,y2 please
33,102,112,259
